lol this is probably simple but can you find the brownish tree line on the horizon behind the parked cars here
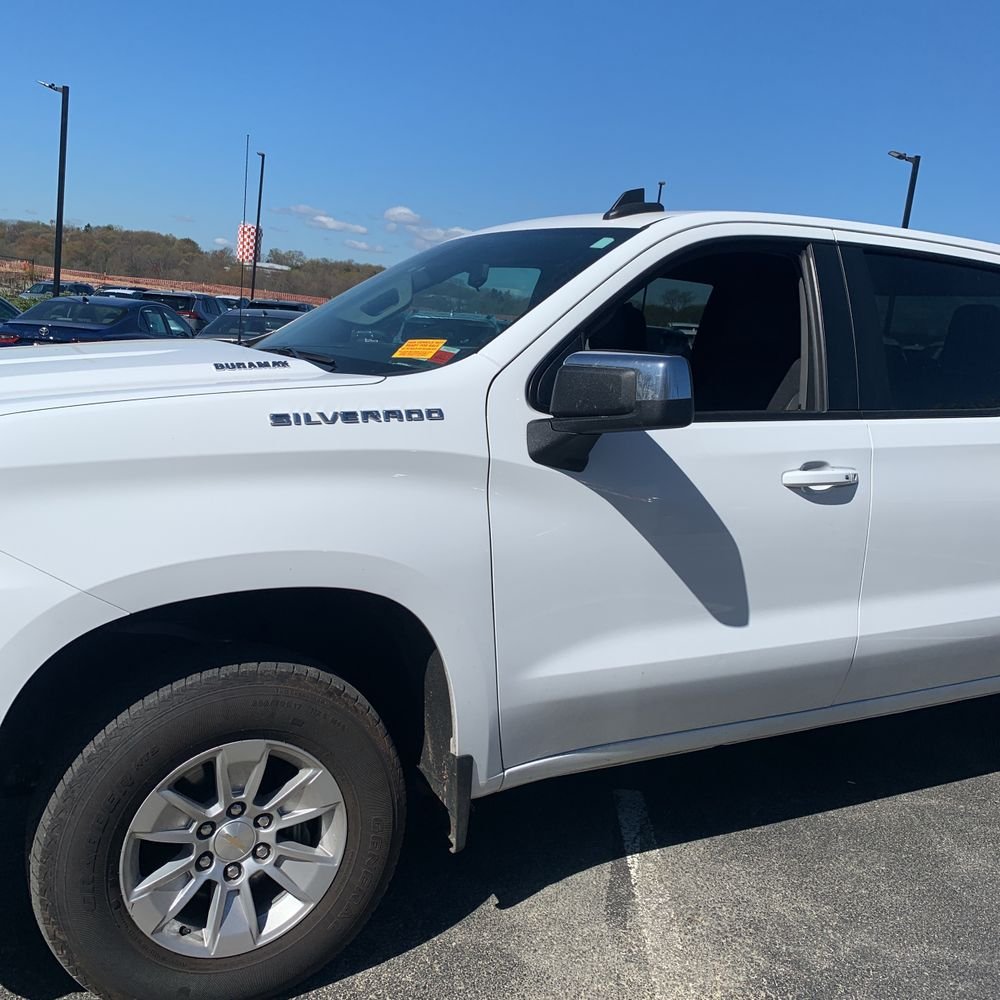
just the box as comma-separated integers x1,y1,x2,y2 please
0,220,382,297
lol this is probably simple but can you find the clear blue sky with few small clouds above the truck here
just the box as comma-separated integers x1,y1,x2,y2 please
0,0,1000,264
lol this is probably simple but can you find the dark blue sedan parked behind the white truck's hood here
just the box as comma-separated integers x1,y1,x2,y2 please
0,295,193,347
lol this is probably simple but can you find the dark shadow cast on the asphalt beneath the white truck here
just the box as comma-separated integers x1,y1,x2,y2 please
0,697,1000,1000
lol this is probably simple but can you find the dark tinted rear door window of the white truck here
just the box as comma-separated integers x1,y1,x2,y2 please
845,248,1000,413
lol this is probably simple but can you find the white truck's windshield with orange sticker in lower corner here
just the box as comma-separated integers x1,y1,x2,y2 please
255,227,636,375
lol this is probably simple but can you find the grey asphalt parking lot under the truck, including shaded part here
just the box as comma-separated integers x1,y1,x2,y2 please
0,698,1000,1000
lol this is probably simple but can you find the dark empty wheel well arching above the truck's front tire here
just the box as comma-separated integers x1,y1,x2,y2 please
0,588,454,828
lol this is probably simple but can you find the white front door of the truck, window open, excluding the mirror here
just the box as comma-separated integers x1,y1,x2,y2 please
487,225,871,769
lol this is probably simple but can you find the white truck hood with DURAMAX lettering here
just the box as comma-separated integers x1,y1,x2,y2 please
0,340,382,414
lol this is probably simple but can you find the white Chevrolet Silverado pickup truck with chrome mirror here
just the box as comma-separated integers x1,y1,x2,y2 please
0,191,1000,1000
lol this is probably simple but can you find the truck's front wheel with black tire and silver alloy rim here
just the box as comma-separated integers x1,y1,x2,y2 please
30,663,405,1000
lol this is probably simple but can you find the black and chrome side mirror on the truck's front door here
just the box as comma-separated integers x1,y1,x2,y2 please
528,351,694,472
